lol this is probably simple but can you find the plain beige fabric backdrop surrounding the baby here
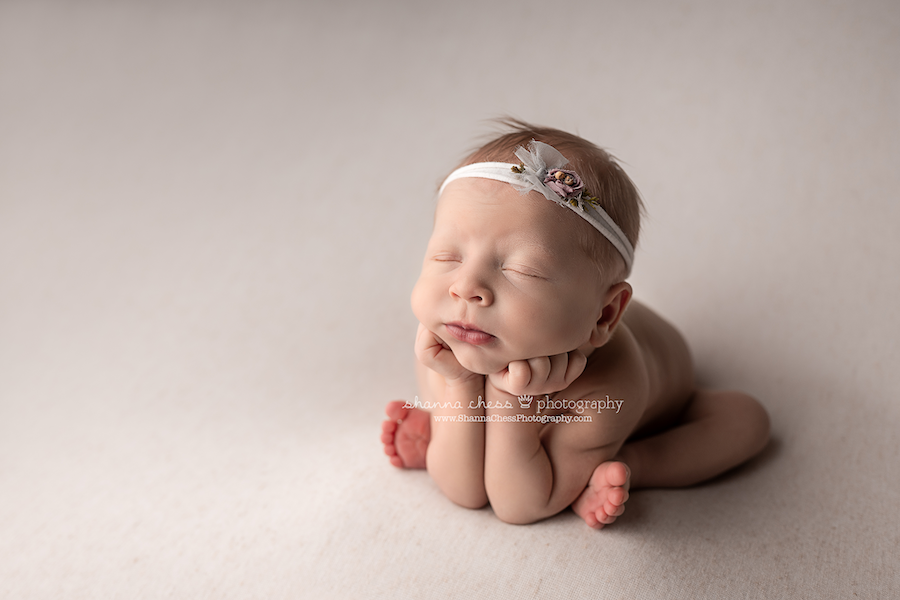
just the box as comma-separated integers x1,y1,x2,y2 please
0,0,900,599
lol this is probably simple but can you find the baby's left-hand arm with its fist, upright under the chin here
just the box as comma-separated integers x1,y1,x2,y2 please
416,324,487,508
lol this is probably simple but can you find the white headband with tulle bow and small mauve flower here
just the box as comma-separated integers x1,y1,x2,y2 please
438,140,634,275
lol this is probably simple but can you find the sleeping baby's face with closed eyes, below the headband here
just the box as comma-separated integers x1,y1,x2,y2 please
412,178,605,375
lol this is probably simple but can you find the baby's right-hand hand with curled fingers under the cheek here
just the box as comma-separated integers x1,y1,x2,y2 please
488,350,587,396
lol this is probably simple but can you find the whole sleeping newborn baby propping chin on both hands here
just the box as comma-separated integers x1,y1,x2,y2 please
381,122,769,528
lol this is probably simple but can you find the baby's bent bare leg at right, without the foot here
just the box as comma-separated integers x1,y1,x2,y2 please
612,390,769,493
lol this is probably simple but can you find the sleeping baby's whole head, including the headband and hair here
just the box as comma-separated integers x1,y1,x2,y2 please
412,121,641,374
